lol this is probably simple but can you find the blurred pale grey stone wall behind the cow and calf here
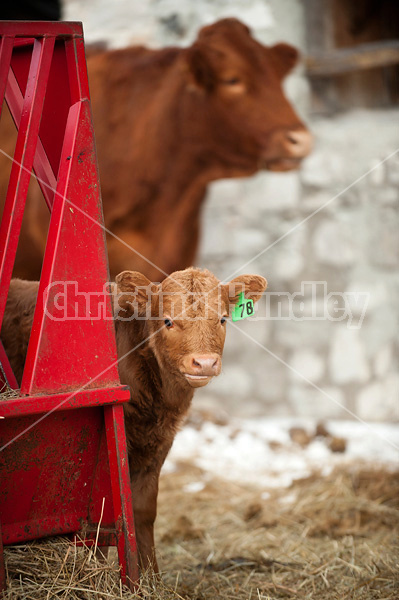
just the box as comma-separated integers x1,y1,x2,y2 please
64,0,399,420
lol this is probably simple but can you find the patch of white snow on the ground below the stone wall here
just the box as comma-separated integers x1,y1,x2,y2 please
164,418,399,493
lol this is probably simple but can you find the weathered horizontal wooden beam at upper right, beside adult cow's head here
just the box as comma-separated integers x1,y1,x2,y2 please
305,40,399,77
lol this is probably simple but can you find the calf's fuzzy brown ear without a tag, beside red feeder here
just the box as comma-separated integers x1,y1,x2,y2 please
114,271,158,316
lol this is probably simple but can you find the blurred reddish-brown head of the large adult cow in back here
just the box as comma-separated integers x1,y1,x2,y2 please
185,19,312,176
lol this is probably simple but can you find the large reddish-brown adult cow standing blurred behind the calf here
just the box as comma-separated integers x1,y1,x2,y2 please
0,19,311,281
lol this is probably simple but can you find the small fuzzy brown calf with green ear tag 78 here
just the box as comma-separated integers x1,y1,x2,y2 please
1,268,266,570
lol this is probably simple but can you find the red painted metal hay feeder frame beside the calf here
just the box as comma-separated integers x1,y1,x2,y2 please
0,21,138,590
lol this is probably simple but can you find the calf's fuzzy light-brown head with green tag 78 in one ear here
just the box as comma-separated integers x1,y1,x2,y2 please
115,268,267,387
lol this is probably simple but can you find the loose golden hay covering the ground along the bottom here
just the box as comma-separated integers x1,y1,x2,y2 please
4,463,399,600
